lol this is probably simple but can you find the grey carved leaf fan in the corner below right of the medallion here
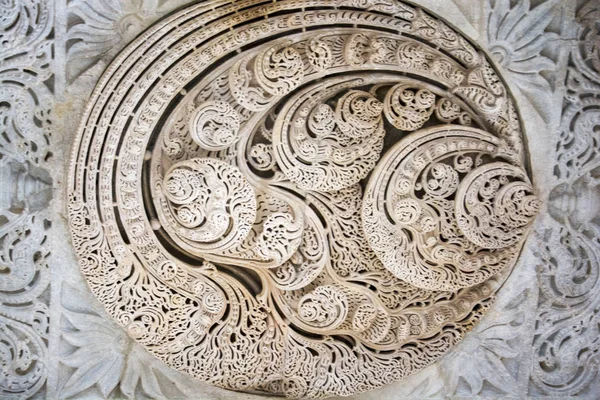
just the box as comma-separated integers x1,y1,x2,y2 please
384,286,535,399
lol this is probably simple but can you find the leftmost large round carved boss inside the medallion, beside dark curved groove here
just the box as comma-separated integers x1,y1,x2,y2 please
158,158,256,254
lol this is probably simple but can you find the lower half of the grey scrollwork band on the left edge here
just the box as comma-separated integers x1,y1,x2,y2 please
0,212,50,398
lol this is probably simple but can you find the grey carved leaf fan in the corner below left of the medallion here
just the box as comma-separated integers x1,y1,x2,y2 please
58,283,204,399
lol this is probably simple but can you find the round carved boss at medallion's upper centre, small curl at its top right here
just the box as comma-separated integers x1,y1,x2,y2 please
272,85,385,191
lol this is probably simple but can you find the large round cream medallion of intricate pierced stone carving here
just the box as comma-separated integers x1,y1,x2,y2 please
69,0,539,397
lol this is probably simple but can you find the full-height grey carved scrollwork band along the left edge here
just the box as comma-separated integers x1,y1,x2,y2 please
0,0,54,398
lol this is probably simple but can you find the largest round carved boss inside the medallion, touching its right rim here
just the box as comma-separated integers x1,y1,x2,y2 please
362,125,539,290
